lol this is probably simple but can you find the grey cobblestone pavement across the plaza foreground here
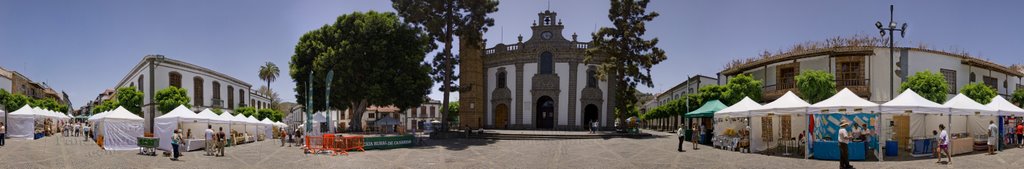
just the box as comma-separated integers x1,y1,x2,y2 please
0,132,1024,169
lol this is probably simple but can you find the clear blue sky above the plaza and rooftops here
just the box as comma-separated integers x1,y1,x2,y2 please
0,0,1024,108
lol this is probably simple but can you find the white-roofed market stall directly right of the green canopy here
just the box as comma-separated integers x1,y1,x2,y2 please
714,97,767,152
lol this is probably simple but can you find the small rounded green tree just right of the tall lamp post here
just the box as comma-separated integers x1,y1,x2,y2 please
899,70,949,102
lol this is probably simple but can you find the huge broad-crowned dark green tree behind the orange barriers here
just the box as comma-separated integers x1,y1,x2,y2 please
290,11,433,131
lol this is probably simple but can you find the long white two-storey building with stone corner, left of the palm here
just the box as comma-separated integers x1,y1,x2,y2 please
115,55,270,131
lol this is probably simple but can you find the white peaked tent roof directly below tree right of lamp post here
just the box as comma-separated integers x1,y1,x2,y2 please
882,89,949,114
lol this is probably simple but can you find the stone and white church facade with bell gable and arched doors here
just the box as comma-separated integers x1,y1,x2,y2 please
460,11,615,130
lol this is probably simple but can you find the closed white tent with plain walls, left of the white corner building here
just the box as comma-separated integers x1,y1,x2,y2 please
95,107,142,151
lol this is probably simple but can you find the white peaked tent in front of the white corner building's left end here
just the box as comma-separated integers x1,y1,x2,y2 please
154,105,207,151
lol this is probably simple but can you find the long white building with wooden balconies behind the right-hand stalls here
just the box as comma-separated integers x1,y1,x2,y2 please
719,46,1024,102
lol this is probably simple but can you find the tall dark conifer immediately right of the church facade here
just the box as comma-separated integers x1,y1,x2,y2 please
585,0,667,121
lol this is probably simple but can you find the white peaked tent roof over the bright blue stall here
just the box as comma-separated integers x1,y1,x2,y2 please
807,88,879,113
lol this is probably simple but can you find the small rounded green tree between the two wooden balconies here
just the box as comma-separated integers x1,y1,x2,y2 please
797,70,836,103
